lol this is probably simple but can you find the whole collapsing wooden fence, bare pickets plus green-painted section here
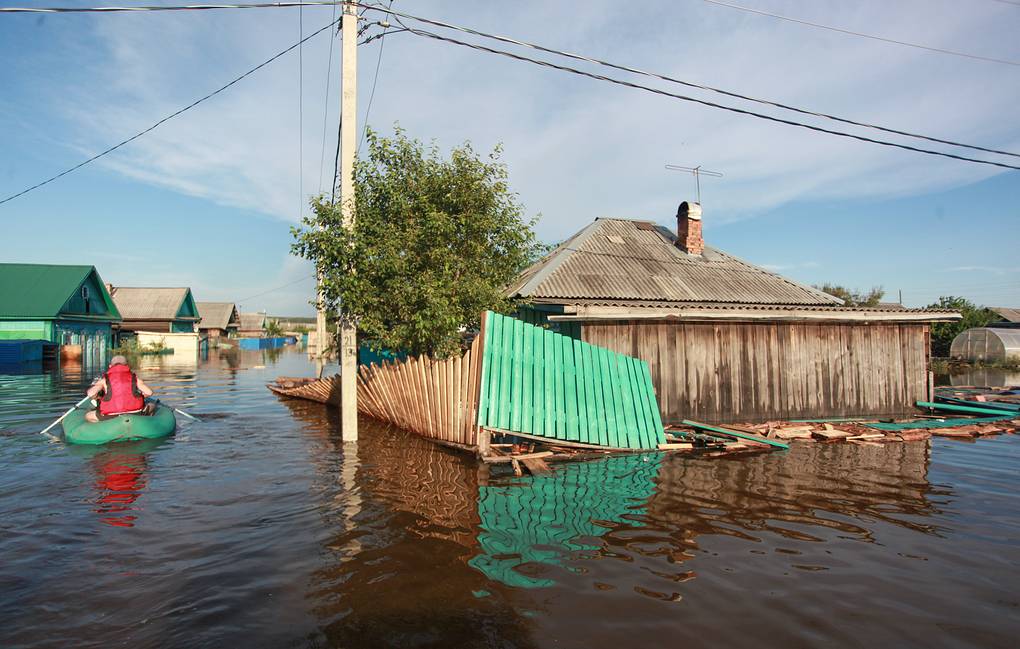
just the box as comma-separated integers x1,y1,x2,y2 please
269,311,666,453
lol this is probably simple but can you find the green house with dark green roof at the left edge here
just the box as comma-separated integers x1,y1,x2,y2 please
0,263,121,355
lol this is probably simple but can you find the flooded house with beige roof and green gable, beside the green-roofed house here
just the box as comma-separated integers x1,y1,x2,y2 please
110,287,201,353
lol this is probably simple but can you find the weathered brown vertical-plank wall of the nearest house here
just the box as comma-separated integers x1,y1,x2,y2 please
581,320,928,423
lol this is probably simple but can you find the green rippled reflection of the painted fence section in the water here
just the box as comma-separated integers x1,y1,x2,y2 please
469,454,662,588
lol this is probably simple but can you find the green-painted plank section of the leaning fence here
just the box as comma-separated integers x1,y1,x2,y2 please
478,311,666,449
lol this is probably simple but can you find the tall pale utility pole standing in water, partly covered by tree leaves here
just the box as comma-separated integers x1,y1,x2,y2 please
339,2,358,442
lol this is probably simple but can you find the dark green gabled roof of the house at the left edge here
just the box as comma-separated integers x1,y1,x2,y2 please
0,263,120,320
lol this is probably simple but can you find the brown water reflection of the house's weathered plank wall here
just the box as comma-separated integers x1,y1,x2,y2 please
649,442,936,541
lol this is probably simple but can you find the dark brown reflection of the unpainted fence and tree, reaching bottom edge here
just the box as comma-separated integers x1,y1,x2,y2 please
284,400,528,647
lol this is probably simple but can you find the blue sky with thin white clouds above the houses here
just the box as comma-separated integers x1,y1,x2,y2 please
0,0,1020,314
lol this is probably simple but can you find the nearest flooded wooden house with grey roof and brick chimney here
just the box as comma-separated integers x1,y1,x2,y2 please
509,202,960,423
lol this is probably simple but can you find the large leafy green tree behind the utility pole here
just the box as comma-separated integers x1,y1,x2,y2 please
292,128,538,356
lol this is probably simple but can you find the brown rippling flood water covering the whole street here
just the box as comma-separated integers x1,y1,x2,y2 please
0,352,1020,649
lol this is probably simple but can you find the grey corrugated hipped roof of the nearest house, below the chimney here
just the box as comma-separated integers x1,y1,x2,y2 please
510,218,842,305
